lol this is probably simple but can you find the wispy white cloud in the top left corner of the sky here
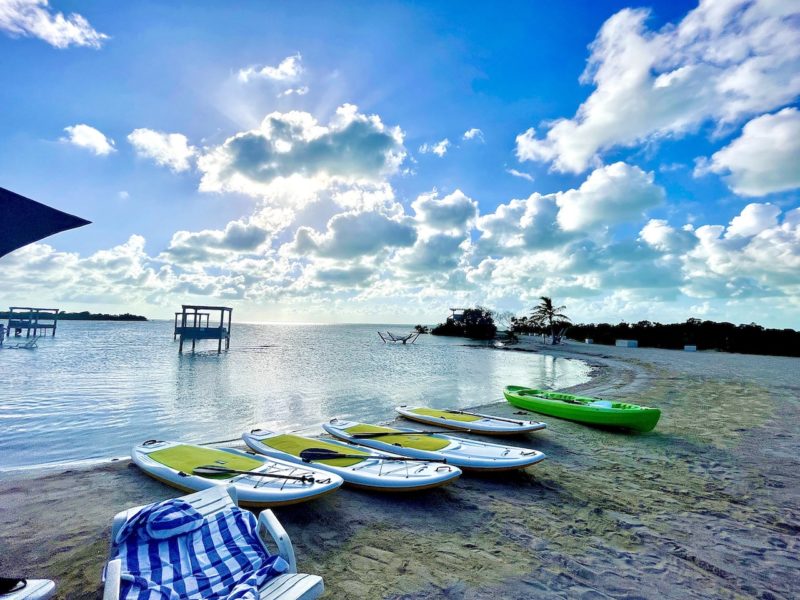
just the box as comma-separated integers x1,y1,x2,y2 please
0,0,108,48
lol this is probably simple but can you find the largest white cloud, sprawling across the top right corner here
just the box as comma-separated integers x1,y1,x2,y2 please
517,0,800,173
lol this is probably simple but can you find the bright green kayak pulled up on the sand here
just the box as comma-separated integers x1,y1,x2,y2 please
503,385,661,431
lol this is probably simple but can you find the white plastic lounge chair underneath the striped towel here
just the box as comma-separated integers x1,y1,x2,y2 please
103,486,325,600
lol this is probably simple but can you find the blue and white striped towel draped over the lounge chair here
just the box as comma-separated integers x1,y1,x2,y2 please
112,499,289,600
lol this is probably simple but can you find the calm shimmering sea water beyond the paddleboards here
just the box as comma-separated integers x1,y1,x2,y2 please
0,321,589,472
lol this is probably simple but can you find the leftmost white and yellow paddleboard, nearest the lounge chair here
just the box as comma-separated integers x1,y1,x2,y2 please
131,441,343,508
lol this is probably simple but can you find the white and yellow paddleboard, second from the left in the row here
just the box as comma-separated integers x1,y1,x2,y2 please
242,429,461,492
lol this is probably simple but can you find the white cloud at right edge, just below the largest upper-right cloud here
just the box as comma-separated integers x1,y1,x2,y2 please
696,108,800,196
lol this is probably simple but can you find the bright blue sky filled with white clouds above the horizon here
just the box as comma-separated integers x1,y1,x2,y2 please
0,0,800,327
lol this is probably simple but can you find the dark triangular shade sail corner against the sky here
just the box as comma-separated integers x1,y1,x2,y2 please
0,188,91,256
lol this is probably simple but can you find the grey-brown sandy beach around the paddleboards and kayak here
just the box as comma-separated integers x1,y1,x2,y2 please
0,341,800,600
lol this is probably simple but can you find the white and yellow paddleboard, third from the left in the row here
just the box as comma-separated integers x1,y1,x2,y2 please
323,419,545,471
